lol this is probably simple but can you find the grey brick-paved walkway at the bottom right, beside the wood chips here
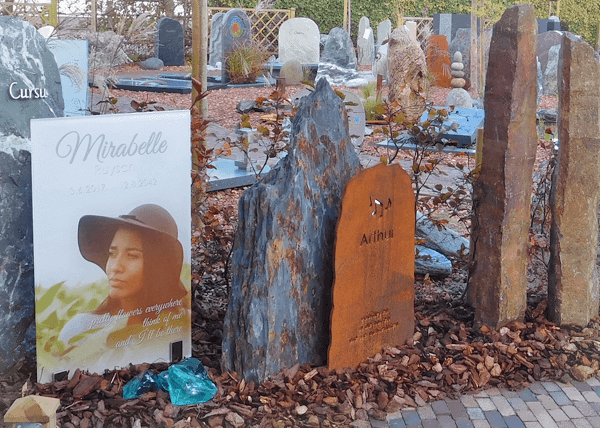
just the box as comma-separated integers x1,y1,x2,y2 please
368,378,600,428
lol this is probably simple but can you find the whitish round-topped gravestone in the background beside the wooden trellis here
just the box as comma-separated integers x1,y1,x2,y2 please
279,18,321,64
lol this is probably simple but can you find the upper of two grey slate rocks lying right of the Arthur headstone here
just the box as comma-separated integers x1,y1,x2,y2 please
415,213,469,257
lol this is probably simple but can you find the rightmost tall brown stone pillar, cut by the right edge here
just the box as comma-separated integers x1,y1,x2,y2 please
548,33,600,326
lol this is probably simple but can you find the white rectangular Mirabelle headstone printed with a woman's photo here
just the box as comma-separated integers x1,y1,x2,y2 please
31,111,191,382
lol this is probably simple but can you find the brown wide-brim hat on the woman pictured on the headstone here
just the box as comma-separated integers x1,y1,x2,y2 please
78,204,183,278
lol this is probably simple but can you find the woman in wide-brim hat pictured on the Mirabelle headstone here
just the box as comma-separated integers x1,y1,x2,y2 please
59,204,187,347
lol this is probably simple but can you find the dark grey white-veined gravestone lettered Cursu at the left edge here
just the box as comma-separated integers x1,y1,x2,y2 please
0,16,64,372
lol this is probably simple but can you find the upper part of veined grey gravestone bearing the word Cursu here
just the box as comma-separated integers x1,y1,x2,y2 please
0,16,64,138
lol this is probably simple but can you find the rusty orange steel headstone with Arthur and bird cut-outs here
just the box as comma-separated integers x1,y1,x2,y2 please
328,165,415,369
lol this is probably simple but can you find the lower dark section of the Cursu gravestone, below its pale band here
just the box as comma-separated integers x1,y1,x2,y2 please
0,150,35,372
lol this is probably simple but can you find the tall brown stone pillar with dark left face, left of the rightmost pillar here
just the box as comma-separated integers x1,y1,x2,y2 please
468,4,537,327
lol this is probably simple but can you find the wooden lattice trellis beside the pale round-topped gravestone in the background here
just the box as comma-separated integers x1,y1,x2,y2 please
208,7,296,52
